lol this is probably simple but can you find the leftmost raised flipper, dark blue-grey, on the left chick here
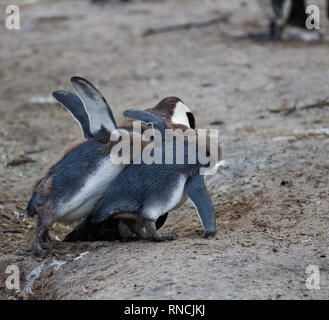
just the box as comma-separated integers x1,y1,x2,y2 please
53,90,94,139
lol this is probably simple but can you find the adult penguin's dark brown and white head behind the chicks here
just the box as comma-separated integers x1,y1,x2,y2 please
146,97,195,129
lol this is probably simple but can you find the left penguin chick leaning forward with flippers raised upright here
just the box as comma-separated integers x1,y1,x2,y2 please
27,77,158,255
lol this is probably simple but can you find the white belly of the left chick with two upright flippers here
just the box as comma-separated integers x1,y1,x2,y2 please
58,157,123,221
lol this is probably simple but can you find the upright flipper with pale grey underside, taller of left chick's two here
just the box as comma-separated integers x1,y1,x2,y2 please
71,77,117,135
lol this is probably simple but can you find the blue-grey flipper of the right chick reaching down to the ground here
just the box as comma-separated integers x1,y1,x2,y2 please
185,175,216,237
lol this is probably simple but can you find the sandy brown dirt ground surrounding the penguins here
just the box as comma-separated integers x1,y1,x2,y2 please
0,0,329,299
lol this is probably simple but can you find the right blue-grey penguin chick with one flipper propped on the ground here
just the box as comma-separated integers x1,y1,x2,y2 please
92,110,220,241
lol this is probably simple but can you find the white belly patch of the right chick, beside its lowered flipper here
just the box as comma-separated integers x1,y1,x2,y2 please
143,175,187,220
